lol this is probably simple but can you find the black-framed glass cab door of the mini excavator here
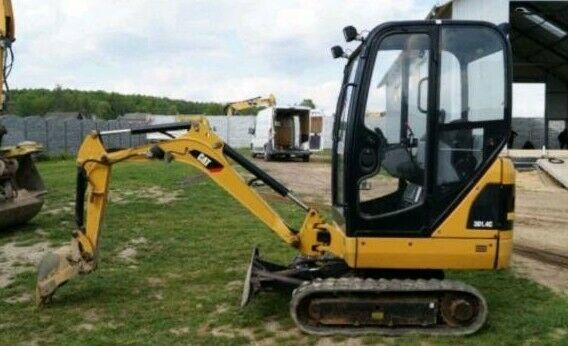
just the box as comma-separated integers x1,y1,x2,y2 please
345,25,436,236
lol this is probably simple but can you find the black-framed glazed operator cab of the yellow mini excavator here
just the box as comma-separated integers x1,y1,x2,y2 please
332,21,512,237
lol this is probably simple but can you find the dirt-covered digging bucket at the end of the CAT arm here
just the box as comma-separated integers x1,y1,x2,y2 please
36,240,90,305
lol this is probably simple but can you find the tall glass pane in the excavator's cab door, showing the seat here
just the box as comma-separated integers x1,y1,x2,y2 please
359,33,430,217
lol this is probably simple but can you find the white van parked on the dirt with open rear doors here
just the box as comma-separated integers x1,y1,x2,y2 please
249,107,311,162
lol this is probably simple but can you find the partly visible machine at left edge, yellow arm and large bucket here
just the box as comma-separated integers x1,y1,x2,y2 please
0,0,46,230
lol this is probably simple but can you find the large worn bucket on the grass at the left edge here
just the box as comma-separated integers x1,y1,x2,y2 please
0,142,47,230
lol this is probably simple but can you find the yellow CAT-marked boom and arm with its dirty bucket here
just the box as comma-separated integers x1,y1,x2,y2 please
36,118,342,303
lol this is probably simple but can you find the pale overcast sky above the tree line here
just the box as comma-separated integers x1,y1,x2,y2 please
10,0,540,117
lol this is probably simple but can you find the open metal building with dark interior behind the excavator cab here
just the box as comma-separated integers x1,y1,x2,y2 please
428,0,568,148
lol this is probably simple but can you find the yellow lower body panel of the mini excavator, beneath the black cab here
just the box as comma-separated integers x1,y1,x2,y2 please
322,158,515,269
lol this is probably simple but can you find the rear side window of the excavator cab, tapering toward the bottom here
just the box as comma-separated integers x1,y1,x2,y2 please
436,26,507,197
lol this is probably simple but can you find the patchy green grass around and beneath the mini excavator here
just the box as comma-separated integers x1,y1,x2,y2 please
0,161,568,345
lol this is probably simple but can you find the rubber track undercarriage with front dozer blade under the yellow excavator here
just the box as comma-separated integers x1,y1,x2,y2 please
241,249,487,335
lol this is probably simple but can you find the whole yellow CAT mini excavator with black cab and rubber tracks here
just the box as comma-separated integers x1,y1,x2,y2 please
36,21,515,335
